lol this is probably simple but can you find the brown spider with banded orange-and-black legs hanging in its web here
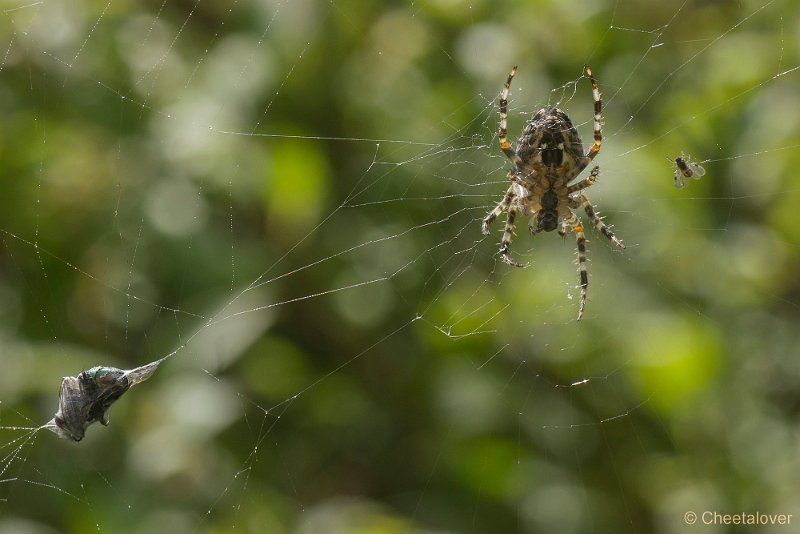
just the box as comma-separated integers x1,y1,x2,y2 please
481,65,625,320
